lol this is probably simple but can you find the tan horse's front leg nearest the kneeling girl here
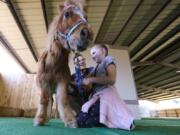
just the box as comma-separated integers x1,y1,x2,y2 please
56,82,77,128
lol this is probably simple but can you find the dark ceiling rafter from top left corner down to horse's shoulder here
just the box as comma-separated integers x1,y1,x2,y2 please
6,0,38,62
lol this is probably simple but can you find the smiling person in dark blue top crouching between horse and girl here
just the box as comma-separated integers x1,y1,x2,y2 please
68,54,94,113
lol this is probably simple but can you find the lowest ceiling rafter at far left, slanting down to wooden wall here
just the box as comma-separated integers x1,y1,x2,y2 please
0,32,30,73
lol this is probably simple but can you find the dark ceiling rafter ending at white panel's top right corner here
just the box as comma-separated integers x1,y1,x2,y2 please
127,0,171,46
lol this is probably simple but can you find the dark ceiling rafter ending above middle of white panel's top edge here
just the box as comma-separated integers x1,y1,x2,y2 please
111,0,143,45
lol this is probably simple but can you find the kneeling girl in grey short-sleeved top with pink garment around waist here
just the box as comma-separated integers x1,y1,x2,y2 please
77,44,134,130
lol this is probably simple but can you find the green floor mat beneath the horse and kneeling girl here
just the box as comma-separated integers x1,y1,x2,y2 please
0,118,180,135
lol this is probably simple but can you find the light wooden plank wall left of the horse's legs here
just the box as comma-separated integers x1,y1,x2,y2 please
0,74,40,109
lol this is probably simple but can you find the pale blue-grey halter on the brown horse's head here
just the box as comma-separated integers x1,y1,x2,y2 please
56,5,87,49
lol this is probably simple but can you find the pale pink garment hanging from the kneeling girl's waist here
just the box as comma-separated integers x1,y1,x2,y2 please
82,86,134,130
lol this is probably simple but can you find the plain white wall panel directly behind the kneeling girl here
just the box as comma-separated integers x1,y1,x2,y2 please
110,49,140,119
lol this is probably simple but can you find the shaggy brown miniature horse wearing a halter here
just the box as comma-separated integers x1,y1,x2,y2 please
34,0,93,128
